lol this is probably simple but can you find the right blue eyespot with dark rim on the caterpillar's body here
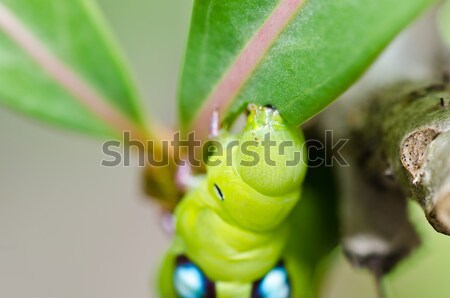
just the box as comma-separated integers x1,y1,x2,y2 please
252,263,291,298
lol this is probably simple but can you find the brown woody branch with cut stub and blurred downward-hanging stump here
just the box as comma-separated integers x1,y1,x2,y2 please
333,82,450,277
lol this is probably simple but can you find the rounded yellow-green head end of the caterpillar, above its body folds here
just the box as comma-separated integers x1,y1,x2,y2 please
207,105,306,231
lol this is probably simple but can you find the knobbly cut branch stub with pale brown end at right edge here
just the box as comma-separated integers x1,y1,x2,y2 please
359,82,450,234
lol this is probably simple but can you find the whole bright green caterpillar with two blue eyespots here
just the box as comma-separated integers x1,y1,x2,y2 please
159,105,308,298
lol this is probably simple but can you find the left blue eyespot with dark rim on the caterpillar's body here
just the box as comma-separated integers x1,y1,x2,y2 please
173,256,215,298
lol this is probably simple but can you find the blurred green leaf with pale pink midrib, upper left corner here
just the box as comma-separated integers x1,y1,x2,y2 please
0,0,143,136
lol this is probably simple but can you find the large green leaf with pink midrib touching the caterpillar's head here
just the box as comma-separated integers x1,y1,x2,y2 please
179,0,434,136
